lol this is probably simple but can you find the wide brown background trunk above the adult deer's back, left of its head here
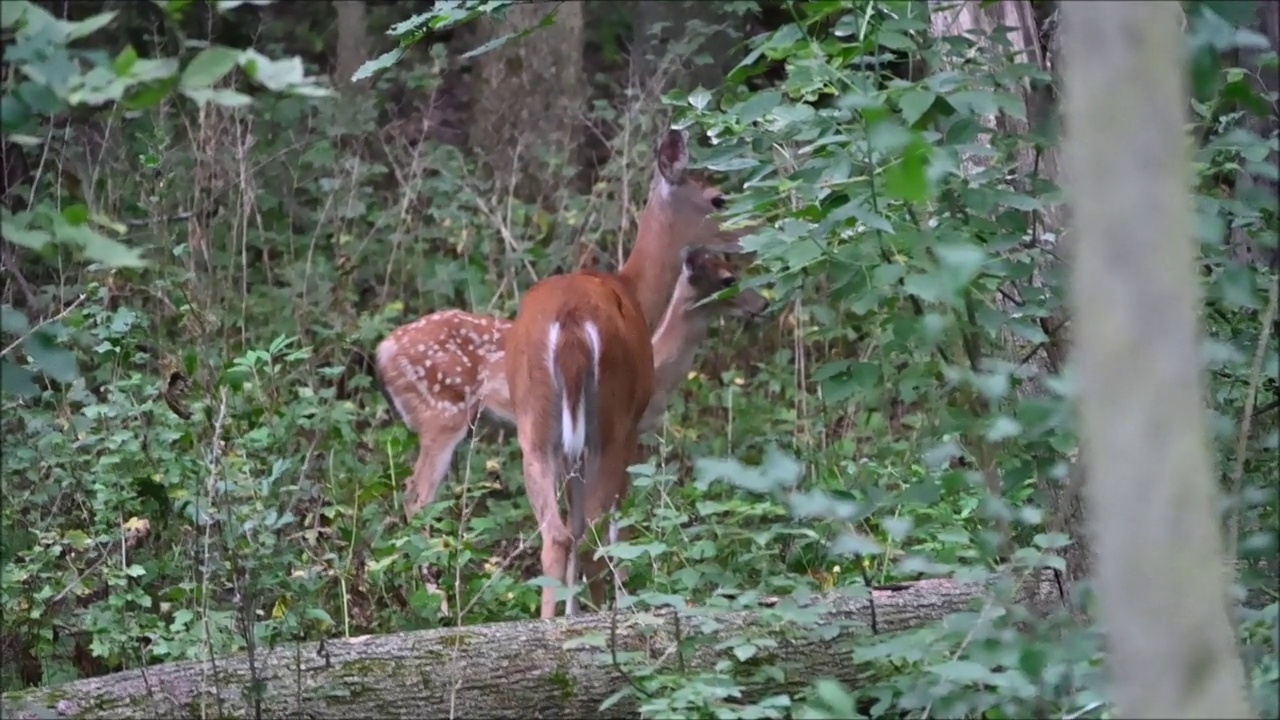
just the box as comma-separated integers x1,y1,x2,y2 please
471,1,588,201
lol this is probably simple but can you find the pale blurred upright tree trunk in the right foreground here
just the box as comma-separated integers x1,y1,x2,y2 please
1062,3,1251,717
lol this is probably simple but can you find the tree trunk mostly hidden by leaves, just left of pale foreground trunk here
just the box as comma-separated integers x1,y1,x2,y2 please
929,0,1091,585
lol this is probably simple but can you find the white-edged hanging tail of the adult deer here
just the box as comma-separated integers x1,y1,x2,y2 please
547,310,600,615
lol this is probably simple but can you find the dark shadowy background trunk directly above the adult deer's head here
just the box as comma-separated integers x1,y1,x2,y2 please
631,0,742,95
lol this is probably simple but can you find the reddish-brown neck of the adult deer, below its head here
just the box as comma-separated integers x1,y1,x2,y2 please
618,198,680,332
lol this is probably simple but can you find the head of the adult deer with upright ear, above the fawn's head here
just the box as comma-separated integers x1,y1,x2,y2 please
645,129,745,251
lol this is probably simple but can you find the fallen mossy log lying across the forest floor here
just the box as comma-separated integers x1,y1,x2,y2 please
0,573,1060,720
